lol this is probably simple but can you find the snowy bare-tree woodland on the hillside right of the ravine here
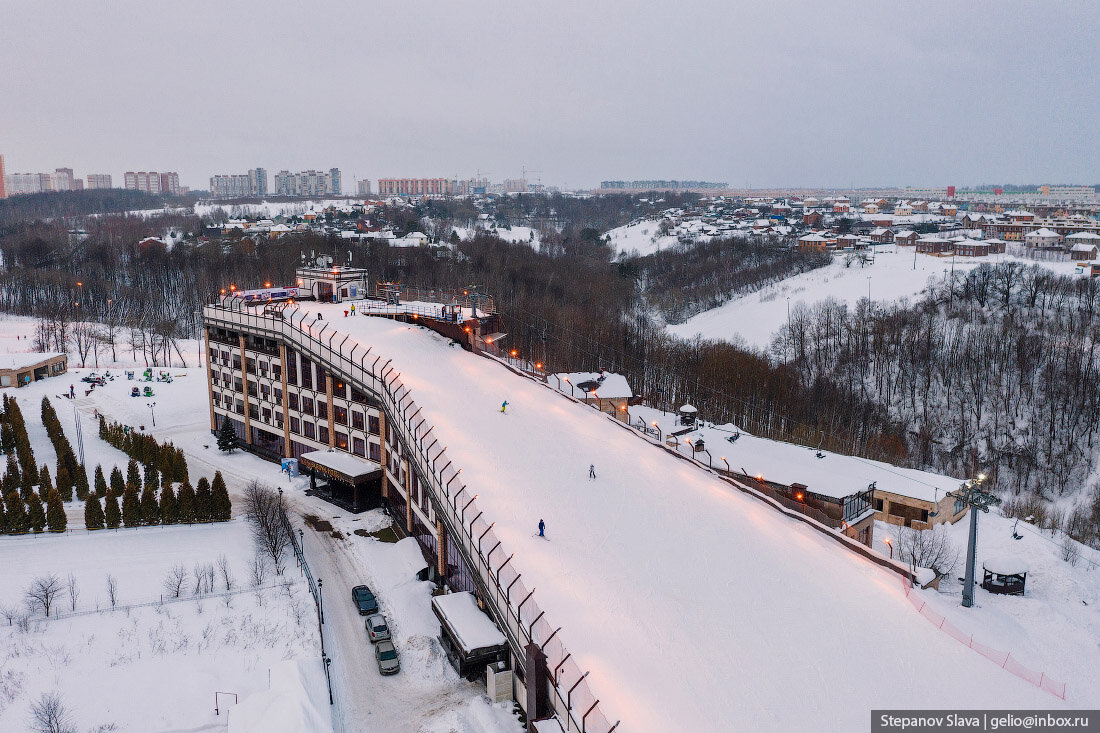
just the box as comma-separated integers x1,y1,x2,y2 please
772,263,1100,541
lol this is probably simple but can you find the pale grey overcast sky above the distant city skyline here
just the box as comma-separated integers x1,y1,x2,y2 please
0,0,1100,190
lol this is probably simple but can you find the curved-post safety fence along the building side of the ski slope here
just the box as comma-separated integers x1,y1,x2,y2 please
202,298,619,733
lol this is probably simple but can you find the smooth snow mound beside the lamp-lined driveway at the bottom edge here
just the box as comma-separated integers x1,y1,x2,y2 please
229,659,332,733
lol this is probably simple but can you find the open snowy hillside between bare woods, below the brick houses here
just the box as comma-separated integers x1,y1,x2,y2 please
668,244,1076,349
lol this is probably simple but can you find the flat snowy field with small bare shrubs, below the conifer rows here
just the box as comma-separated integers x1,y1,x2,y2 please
0,519,320,733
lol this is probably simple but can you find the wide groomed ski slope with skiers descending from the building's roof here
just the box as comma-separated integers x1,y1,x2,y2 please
301,303,1073,731
